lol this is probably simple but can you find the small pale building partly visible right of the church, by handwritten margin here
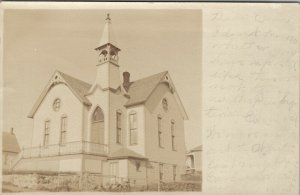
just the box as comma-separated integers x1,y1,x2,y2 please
187,145,202,173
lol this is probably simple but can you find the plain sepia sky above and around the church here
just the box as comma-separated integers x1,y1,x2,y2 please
3,9,202,149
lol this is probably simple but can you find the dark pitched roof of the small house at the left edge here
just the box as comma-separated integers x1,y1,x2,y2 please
2,132,21,153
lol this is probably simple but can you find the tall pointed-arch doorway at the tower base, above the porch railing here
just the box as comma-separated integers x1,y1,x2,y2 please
90,107,104,144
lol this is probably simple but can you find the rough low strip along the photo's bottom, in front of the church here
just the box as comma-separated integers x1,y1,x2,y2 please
3,172,201,192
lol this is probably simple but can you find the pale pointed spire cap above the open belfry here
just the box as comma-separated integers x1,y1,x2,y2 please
96,13,117,50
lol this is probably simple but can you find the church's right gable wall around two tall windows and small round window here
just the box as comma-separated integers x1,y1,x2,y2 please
145,84,186,167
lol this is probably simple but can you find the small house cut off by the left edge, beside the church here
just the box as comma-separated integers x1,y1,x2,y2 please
2,128,21,172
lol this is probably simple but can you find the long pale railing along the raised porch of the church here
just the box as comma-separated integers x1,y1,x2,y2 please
22,141,108,158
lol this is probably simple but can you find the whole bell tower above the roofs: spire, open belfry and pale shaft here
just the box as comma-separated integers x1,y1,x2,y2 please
95,14,121,89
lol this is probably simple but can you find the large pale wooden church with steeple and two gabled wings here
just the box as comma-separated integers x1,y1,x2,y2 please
13,15,188,184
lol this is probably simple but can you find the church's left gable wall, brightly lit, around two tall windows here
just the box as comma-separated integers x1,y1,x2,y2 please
32,84,83,147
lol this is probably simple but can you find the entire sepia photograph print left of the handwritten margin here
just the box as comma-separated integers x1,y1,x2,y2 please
2,8,203,192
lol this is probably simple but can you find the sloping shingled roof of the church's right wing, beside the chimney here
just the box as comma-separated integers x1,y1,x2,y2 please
125,71,168,106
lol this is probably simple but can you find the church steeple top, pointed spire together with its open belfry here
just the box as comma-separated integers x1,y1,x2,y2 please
95,14,120,65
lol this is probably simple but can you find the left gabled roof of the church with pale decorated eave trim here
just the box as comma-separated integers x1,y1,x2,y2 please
28,71,92,118
